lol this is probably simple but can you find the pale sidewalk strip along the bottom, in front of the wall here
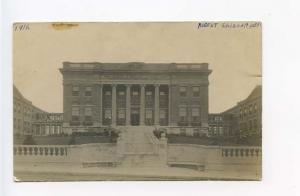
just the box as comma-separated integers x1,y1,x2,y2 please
14,164,259,181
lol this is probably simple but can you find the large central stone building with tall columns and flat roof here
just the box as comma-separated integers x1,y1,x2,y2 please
60,62,211,132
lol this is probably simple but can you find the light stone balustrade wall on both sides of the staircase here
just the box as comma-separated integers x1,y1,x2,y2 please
14,141,261,174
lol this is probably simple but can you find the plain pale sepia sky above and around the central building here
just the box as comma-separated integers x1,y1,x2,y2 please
13,22,262,113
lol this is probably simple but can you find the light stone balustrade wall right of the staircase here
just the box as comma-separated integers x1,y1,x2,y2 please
168,144,261,173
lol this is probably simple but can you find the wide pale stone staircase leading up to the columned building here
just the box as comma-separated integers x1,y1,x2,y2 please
117,126,167,167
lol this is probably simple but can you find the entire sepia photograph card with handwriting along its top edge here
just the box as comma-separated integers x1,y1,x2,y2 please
12,21,262,182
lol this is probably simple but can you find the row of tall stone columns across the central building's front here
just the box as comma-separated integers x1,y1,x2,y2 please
100,84,160,126
